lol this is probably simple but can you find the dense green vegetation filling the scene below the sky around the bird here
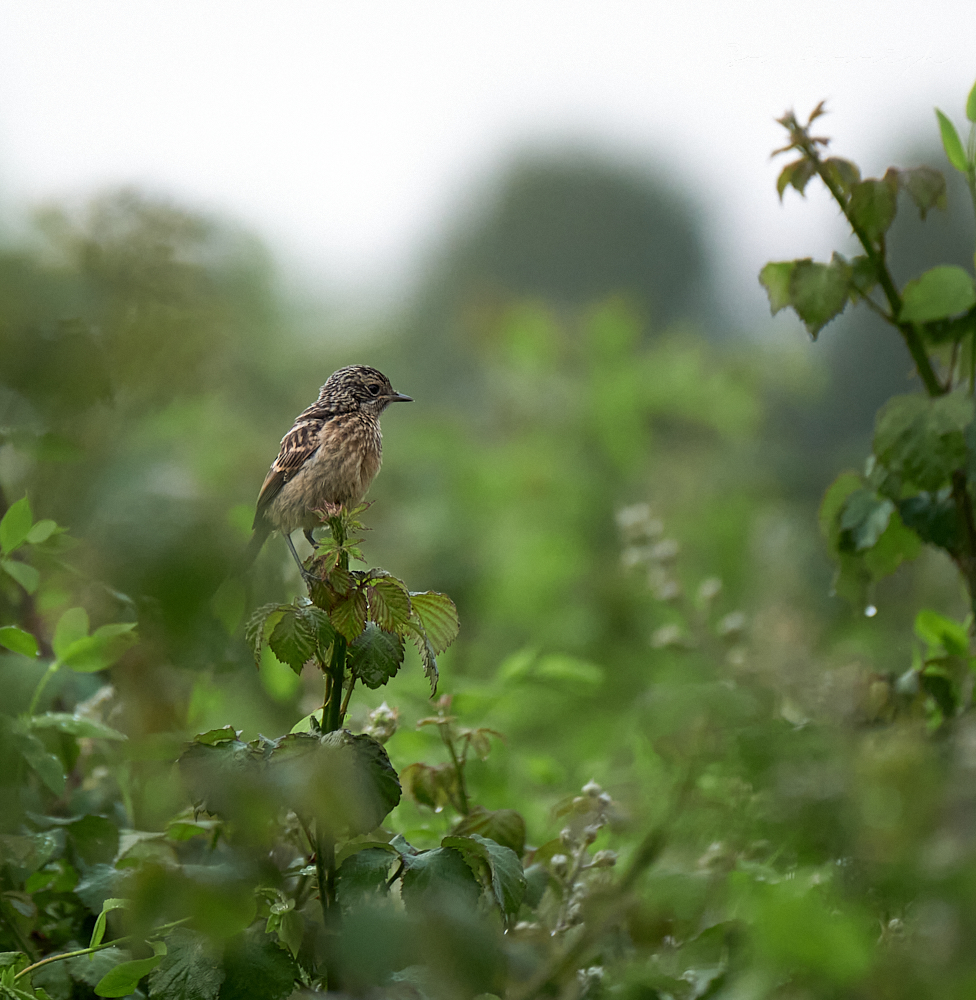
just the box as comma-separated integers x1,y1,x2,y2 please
0,82,976,1000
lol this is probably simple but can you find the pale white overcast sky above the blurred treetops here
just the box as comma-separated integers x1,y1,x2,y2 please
0,0,976,321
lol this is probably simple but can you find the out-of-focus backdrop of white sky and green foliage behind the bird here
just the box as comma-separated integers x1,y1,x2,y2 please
0,0,976,992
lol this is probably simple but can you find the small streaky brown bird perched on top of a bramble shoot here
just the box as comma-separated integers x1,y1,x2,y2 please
244,365,413,579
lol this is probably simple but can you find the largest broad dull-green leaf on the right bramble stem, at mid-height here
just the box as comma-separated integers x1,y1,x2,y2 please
874,392,974,491
